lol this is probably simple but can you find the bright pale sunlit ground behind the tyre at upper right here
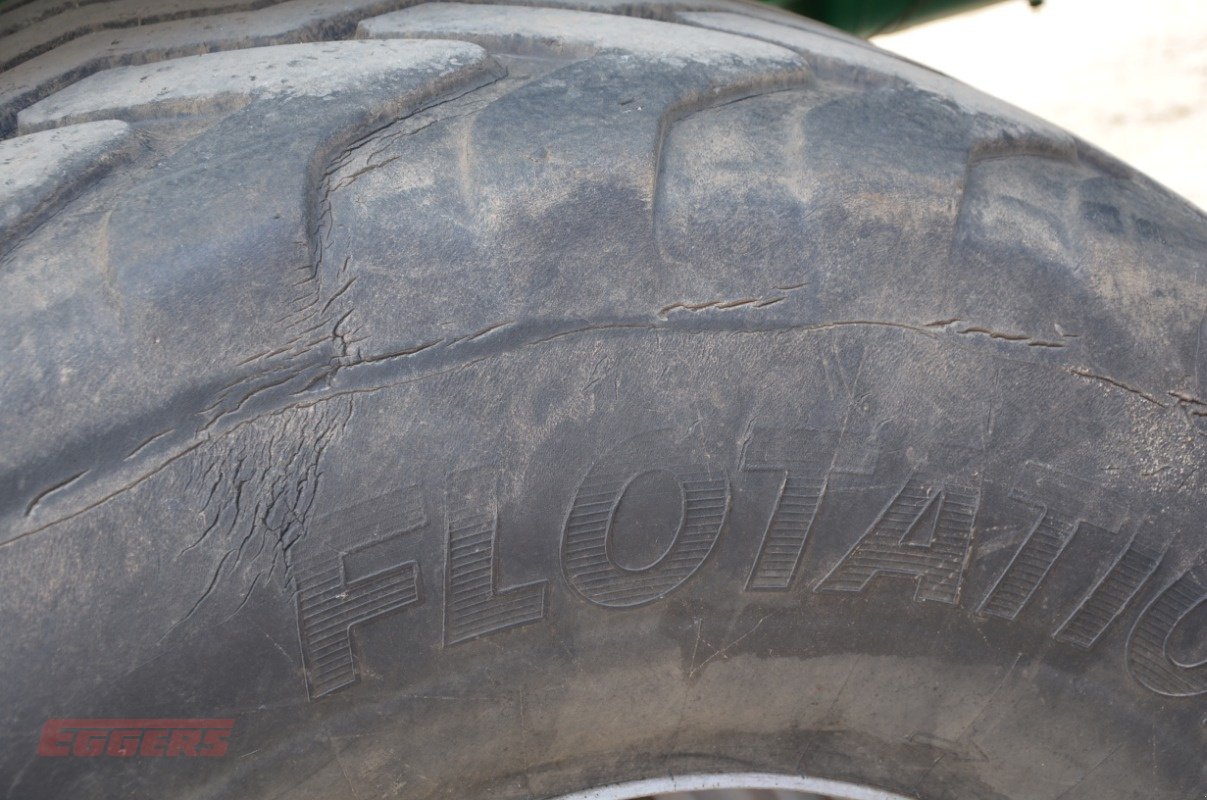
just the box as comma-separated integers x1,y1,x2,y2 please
874,0,1207,209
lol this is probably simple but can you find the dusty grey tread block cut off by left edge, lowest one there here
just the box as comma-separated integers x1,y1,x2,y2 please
0,119,130,241
